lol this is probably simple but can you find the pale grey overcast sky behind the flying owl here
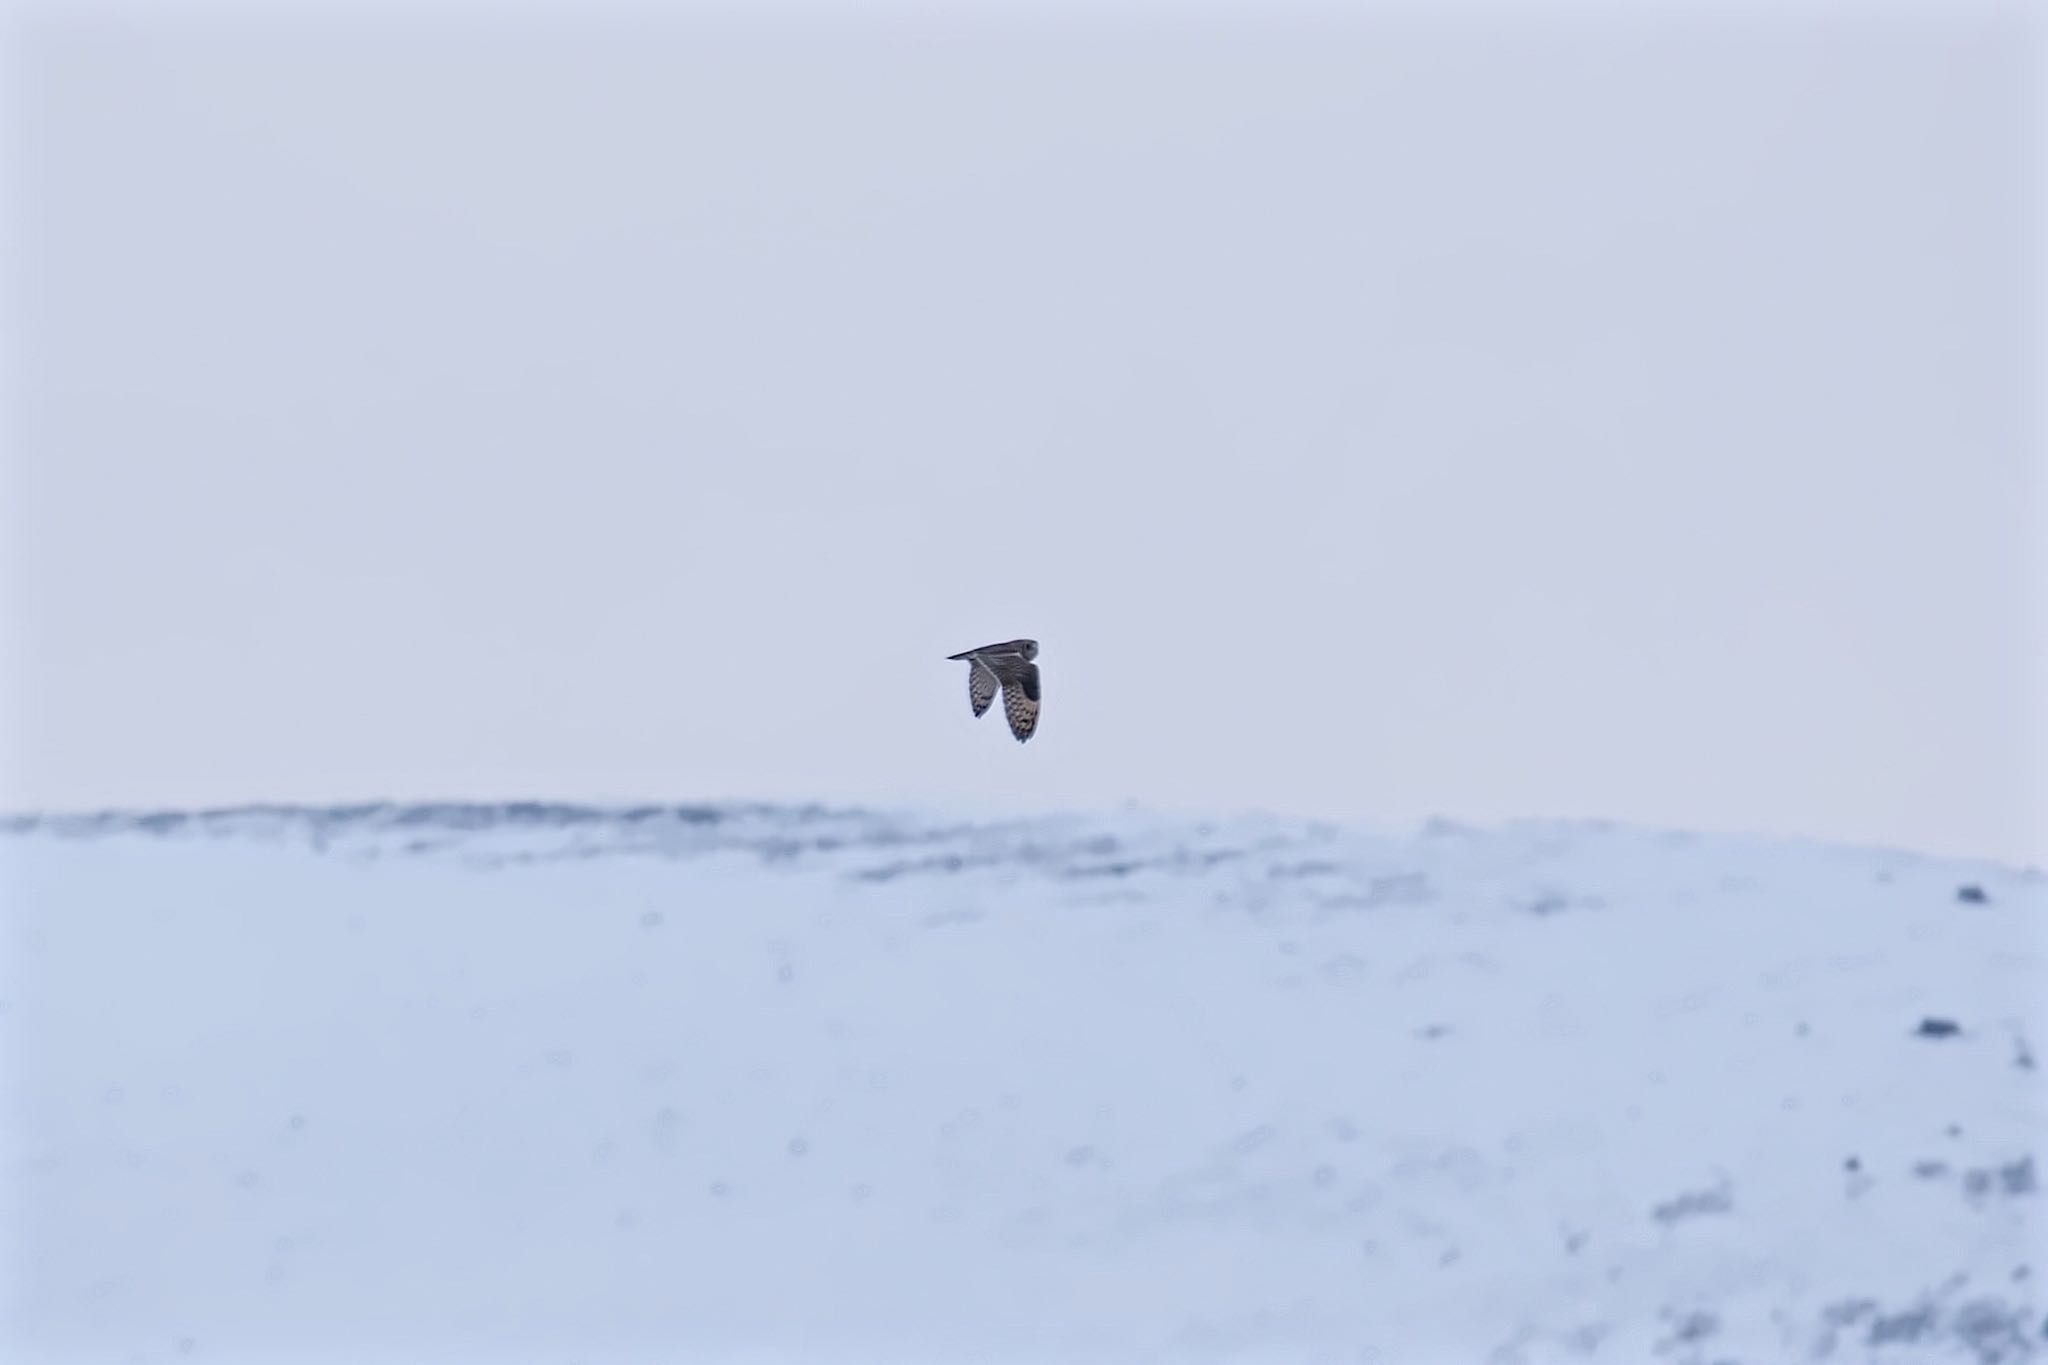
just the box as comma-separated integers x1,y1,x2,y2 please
0,4,2048,860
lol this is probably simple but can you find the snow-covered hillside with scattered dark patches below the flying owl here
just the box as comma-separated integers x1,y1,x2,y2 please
0,804,2048,1365
